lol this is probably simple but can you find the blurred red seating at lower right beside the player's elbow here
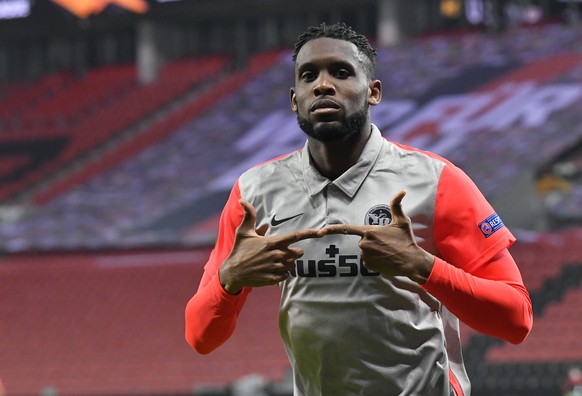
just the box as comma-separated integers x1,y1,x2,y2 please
463,228,582,396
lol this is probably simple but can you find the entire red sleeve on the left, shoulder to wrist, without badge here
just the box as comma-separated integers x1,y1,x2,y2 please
185,182,251,354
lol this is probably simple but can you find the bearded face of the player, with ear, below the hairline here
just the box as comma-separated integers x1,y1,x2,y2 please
290,38,381,142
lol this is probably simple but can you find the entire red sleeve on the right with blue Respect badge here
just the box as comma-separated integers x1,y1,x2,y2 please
424,164,533,343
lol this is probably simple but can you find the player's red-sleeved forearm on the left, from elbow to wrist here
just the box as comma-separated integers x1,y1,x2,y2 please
185,275,249,354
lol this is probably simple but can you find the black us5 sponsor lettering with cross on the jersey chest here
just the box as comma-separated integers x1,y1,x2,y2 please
290,245,380,278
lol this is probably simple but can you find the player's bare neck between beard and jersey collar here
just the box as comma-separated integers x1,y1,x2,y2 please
308,124,372,180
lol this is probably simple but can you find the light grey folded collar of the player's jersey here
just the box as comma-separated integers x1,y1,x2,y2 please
301,124,384,198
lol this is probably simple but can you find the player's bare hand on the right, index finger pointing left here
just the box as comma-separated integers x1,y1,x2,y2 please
321,190,434,284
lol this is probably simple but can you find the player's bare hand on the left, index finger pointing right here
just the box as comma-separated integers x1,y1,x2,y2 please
219,199,322,294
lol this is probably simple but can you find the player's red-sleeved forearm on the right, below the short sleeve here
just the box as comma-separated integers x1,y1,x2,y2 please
423,253,533,344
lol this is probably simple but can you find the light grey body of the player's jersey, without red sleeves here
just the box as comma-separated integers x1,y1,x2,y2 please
239,126,488,396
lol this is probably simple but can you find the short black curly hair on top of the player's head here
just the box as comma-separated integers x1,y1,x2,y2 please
293,22,377,78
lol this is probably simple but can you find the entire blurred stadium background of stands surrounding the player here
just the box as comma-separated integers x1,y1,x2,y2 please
0,0,582,396
